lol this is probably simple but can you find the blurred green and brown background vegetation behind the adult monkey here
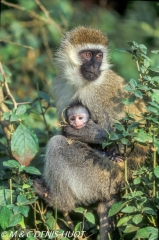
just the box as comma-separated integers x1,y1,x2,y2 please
0,0,159,167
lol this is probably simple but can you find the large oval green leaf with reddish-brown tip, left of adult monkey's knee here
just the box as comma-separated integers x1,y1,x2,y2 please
11,124,39,166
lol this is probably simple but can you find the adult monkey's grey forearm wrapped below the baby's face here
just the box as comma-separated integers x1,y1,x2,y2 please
63,120,107,144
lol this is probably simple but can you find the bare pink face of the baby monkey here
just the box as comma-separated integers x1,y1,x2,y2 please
69,113,88,129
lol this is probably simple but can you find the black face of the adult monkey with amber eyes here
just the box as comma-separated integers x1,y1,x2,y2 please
79,50,103,81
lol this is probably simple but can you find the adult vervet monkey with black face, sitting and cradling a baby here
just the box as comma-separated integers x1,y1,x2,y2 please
37,27,145,240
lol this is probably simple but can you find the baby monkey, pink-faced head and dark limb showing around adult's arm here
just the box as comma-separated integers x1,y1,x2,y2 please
65,103,123,162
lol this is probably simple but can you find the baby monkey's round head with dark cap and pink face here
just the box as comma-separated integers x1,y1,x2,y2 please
65,103,91,129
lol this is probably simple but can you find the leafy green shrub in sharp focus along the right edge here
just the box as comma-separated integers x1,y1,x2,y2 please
107,42,159,240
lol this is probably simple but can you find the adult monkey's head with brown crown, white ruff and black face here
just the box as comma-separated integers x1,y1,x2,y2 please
57,27,110,87
